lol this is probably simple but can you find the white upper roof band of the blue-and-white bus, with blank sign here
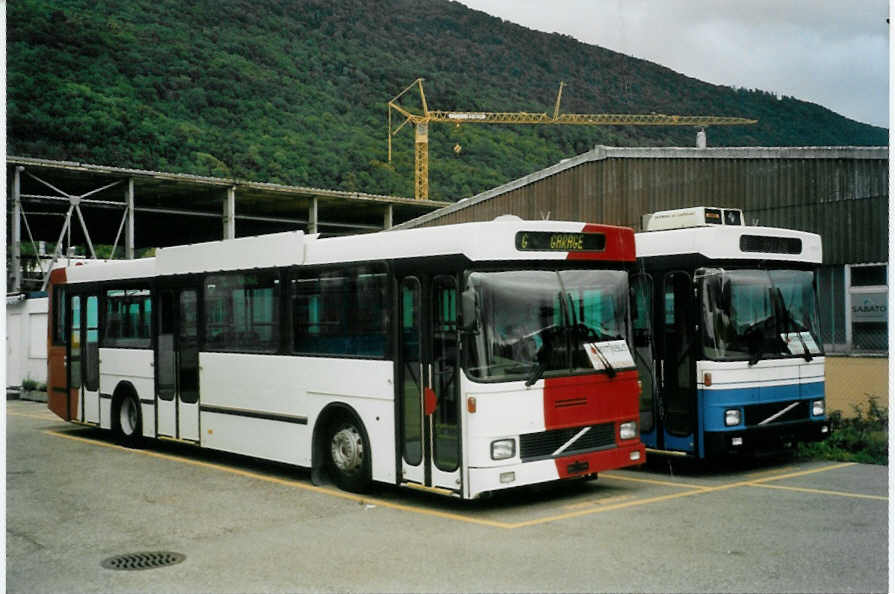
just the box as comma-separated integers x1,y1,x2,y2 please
635,225,823,264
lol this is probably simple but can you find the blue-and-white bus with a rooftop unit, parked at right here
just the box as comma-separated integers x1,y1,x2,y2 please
632,207,829,459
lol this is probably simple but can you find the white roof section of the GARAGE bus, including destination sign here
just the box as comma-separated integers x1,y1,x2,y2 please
56,217,635,282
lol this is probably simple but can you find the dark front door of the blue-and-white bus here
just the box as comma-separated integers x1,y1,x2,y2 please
659,271,697,452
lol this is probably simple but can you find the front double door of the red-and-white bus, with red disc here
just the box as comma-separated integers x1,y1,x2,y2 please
397,274,462,492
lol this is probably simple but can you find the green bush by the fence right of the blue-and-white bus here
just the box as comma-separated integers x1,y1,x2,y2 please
798,395,889,464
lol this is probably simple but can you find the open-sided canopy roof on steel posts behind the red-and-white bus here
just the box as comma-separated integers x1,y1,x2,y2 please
6,156,450,247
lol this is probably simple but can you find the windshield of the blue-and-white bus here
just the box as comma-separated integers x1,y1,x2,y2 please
696,268,822,365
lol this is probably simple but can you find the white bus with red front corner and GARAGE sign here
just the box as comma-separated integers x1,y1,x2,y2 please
48,217,644,498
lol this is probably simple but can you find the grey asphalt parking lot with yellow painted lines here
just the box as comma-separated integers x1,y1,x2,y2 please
6,401,888,592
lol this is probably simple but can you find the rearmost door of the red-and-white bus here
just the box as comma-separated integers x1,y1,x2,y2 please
67,293,99,425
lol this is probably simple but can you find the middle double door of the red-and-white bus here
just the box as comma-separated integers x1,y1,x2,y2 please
155,288,199,441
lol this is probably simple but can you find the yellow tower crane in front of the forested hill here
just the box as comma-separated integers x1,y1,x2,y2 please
388,78,758,200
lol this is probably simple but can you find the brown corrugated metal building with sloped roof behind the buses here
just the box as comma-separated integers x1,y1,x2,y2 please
396,146,889,351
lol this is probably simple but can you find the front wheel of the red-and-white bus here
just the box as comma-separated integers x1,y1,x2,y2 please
326,417,371,493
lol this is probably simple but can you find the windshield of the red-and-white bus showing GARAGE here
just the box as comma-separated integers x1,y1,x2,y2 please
464,270,634,384
